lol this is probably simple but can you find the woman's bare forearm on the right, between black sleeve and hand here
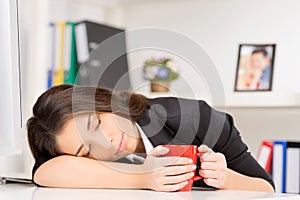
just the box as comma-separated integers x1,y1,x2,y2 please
222,168,274,192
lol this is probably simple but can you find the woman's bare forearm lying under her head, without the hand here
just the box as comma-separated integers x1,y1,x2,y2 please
34,156,144,189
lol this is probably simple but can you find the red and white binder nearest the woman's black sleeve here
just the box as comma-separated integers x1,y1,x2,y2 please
257,140,273,174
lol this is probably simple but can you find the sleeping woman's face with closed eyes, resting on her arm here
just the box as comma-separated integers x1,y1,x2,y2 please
57,113,140,161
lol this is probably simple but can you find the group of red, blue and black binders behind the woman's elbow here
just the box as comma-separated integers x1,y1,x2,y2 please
257,140,300,194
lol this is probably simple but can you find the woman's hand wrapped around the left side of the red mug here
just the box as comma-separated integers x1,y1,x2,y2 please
143,146,196,192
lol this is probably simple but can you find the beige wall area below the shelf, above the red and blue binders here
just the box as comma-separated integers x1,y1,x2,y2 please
227,107,300,155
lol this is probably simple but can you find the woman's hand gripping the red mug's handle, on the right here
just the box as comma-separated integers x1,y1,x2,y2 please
198,145,227,189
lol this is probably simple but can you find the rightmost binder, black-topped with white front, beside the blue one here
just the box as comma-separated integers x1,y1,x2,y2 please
286,142,300,194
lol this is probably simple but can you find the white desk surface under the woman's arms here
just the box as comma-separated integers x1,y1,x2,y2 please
0,184,300,200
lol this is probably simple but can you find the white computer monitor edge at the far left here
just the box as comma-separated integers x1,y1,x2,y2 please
0,0,24,156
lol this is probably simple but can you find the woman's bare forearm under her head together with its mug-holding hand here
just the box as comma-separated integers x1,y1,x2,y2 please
33,148,196,191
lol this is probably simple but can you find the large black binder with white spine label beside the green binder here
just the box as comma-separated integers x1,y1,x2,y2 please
75,21,131,90
